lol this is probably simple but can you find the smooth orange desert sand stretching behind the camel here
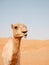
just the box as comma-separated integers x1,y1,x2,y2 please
0,38,49,65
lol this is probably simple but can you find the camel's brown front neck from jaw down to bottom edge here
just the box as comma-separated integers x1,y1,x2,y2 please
9,38,21,65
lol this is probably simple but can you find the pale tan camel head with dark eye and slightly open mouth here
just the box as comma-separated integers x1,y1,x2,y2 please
11,24,28,38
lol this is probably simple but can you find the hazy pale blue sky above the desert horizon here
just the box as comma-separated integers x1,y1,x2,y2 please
0,0,49,40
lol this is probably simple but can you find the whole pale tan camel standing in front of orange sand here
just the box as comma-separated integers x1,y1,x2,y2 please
2,24,28,65
